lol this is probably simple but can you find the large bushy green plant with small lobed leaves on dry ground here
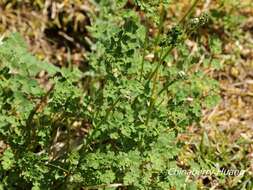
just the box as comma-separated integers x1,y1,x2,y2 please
0,1,218,189
